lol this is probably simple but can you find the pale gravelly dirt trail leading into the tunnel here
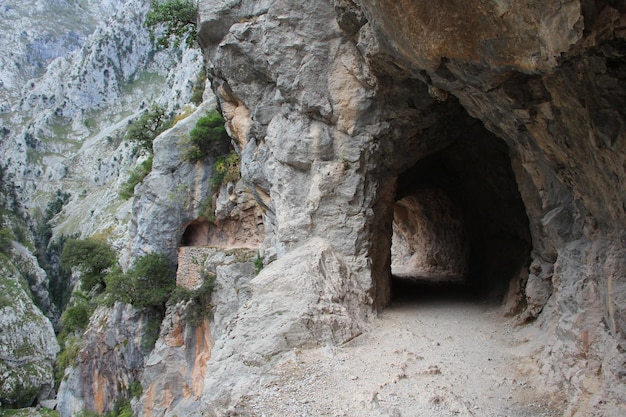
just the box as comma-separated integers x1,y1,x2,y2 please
242,294,562,417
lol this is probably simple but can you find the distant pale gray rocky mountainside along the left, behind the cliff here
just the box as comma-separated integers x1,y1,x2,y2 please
0,0,202,408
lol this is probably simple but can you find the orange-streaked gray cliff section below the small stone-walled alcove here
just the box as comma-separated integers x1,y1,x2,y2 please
137,247,257,417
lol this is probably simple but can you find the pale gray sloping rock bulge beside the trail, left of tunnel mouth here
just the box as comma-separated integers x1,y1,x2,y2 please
197,238,371,415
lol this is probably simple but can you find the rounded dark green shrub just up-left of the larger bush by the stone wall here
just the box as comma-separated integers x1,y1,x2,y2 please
61,238,117,292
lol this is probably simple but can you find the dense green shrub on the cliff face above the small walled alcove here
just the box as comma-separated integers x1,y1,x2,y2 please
181,110,230,163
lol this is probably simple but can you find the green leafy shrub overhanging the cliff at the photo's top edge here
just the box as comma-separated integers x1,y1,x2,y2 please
146,0,198,48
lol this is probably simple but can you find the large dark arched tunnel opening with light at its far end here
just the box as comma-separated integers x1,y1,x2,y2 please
391,116,531,303
